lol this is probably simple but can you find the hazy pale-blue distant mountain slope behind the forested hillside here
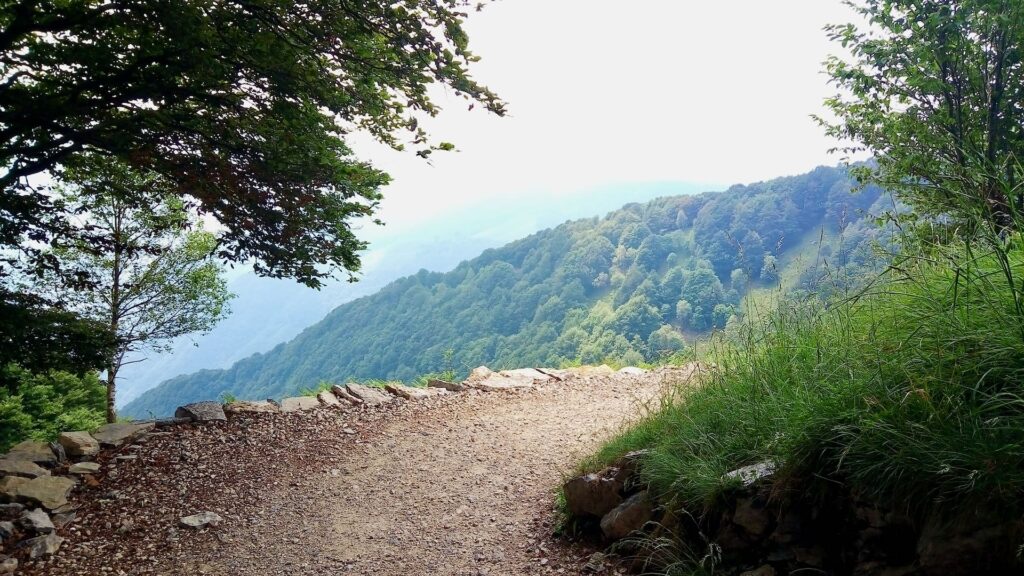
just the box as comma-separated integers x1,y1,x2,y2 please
112,182,707,405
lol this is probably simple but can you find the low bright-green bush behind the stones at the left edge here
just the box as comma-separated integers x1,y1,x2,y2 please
0,363,106,452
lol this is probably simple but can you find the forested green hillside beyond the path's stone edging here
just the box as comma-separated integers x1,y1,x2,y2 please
124,163,890,416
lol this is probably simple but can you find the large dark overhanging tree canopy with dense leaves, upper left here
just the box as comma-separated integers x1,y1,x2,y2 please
0,0,504,286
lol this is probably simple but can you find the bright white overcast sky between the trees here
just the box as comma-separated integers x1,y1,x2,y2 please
354,0,851,236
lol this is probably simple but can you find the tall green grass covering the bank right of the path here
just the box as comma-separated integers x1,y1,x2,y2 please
589,243,1024,517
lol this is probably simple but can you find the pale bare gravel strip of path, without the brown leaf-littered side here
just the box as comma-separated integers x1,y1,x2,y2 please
201,378,656,575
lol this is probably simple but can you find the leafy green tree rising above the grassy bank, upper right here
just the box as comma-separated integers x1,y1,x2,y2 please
822,0,1024,228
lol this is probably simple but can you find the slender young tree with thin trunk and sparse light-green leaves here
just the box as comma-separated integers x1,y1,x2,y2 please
34,158,230,421
